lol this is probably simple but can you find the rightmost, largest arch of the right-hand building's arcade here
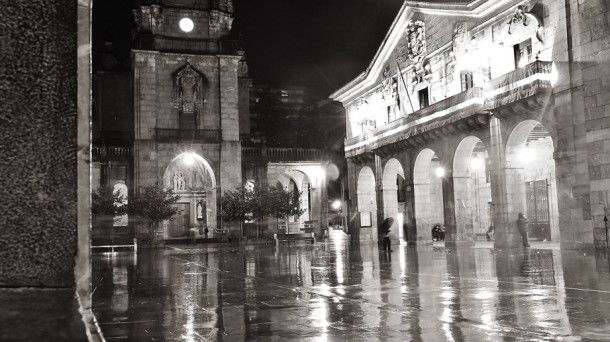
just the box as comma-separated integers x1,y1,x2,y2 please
505,120,559,241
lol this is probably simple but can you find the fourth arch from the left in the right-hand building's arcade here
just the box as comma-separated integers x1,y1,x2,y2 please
453,136,493,241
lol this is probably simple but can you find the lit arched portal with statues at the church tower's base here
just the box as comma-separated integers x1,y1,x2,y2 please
163,152,217,239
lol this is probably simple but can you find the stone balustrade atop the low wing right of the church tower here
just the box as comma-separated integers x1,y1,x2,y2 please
241,147,327,162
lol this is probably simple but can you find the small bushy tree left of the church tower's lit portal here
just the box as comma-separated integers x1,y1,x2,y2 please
128,184,180,245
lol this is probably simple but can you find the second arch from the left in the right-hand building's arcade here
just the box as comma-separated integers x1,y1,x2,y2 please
382,159,405,240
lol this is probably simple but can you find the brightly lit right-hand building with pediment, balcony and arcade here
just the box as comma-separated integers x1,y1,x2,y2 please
331,0,610,248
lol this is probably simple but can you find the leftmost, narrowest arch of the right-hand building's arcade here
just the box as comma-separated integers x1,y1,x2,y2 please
356,166,377,241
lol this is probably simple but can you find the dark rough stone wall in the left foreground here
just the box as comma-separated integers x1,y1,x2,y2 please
0,0,90,341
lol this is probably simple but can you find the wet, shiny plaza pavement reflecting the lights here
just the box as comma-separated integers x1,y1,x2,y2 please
92,232,610,341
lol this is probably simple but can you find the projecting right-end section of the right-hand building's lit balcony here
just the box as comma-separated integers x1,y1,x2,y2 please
485,61,553,118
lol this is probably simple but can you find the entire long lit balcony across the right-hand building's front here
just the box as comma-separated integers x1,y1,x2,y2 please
345,61,552,162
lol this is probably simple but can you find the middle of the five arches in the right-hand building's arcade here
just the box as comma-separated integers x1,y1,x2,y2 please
413,148,445,241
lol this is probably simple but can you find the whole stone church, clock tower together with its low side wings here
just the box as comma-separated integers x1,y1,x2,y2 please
92,0,327,241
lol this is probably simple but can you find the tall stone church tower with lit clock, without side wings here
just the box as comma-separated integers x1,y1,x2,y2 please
132,0,249,240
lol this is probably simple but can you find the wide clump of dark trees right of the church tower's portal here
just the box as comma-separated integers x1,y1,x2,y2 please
221,183,304,238
